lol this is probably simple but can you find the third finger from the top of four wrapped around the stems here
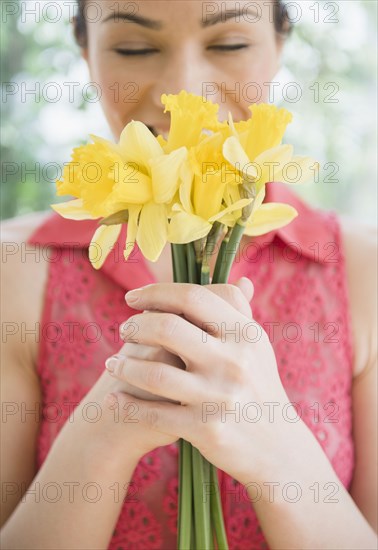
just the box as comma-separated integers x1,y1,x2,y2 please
105,354,206,404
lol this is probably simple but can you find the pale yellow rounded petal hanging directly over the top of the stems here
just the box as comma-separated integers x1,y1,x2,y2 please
168,212,212,244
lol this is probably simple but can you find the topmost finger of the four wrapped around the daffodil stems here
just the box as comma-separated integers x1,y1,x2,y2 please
126,283,245,331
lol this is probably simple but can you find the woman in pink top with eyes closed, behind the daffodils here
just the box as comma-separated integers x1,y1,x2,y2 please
2,0,377,549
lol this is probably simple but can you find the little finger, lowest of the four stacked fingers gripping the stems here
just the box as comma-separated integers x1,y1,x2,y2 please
105,391,194,441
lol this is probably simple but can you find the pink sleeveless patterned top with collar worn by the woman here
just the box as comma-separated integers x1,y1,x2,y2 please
29,183,354,550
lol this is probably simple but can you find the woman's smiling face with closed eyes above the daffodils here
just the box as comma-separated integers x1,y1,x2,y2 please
83,0,282,139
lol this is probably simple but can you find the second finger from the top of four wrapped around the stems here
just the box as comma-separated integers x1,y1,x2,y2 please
120,312,221,369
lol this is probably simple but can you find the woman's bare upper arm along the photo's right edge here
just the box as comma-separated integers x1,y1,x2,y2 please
342,218,378,531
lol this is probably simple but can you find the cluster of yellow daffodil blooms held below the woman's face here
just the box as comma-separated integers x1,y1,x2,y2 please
52,94,316,269
